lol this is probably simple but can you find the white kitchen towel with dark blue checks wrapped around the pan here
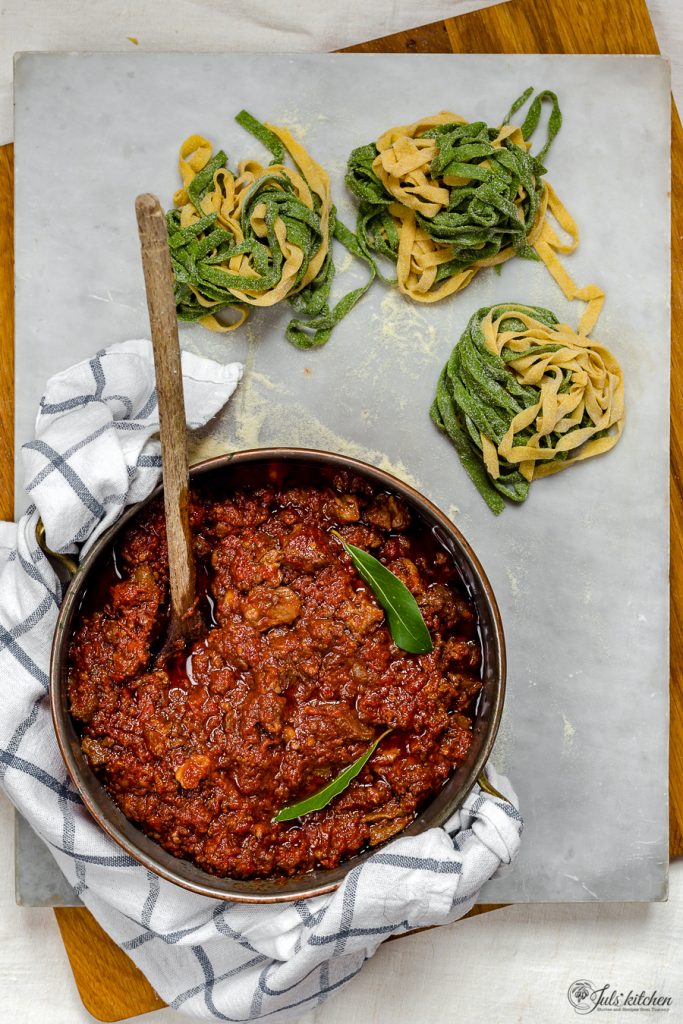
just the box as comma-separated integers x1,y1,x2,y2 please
0,341,522,1021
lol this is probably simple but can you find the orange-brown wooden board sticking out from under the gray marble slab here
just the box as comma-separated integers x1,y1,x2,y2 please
0,0,683,1021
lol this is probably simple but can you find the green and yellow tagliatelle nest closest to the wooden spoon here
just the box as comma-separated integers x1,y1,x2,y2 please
167,111,374,348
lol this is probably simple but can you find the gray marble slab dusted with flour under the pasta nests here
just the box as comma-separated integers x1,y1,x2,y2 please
15,53,670,903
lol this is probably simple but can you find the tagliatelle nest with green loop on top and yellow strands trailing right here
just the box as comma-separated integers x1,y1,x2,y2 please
346,89,603,333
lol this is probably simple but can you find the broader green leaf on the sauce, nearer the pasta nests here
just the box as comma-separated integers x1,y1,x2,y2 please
332,529,433,654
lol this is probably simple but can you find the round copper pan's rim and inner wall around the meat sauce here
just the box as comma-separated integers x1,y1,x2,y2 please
50,447,506,903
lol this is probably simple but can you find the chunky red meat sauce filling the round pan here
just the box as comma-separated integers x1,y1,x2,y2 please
69,467,481,879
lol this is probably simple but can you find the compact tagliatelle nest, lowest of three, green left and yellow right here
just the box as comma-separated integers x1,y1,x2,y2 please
431,303,625,513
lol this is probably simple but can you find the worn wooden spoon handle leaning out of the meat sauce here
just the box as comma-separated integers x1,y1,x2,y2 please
135,194,195,622
